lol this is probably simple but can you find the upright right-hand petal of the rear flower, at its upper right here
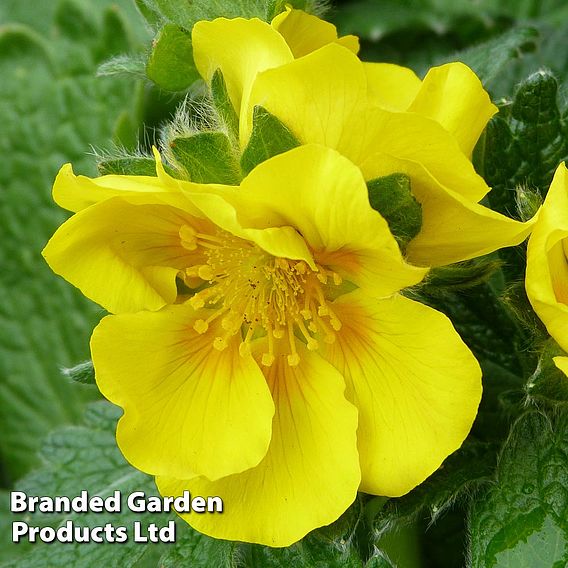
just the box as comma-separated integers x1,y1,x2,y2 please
408,63,498,156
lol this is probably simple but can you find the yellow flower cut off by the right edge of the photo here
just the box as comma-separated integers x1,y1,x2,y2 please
525,163,568,375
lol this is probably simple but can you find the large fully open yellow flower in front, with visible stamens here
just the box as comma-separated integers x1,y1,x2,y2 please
44,145,481,546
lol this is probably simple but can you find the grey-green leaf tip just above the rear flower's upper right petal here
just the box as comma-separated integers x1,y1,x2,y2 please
447,27,539,85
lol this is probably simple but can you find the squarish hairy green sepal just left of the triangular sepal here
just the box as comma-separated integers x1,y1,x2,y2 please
169,132,240,185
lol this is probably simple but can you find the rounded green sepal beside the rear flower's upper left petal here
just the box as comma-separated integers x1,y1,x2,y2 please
146,24,200,91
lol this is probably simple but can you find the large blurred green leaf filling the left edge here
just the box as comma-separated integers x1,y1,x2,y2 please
0,0,144,486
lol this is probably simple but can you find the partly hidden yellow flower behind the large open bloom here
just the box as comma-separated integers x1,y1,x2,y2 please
193,11,532,266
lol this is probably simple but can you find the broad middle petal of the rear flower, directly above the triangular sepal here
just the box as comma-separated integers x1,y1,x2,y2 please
247,44,367,150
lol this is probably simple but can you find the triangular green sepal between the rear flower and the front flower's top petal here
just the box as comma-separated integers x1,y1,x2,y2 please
241,105,300,174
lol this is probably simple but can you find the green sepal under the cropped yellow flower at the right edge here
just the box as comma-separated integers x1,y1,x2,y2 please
525,339,568,404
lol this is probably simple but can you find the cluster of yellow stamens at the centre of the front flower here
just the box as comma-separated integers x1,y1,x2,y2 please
180,227,342,366
